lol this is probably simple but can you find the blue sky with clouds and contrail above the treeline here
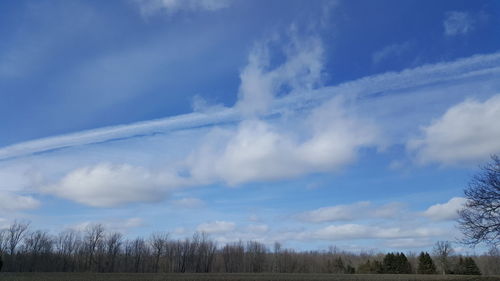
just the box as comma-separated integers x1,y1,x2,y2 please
0,0,500,253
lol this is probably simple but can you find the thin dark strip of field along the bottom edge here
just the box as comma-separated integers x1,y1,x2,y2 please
0,273,500,281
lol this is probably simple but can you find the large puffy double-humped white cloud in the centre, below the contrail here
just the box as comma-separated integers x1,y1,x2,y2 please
188,99,378,185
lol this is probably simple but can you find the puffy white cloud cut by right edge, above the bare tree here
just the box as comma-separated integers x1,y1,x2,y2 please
407,94,500,165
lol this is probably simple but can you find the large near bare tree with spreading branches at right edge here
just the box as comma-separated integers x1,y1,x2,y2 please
458,155,500,245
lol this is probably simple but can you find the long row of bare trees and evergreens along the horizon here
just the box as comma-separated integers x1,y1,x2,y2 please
0,222,500,275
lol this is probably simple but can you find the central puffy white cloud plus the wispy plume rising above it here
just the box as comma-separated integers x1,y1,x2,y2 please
180,36,378,185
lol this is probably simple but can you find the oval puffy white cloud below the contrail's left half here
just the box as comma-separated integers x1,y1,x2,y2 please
42,163,180,207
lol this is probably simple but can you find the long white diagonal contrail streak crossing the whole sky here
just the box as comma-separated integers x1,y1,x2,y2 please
0,52,500,161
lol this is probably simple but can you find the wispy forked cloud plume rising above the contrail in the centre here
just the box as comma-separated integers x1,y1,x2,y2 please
237,35,323,115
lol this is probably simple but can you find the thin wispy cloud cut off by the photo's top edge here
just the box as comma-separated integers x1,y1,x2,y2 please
135,0,231,16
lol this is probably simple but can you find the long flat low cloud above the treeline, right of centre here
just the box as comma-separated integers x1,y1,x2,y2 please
297,201,403,223
